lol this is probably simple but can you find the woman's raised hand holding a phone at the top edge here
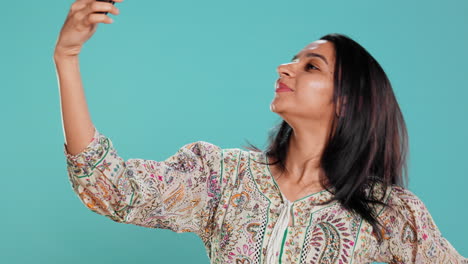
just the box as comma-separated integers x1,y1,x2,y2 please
55,0,124,56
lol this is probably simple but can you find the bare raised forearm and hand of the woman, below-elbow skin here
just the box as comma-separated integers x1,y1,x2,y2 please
53,0,123,154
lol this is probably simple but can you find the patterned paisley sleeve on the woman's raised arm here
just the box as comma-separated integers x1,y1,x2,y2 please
64,128,222,242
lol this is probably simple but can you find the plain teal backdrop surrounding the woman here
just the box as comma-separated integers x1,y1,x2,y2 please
0,0,468,264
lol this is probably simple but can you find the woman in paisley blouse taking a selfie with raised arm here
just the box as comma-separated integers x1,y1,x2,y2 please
54,0,468,263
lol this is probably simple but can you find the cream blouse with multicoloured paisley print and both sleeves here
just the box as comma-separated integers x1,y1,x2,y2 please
64,129,468,264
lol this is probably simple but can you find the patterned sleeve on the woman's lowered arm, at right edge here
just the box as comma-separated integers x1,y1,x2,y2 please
376,187,468,264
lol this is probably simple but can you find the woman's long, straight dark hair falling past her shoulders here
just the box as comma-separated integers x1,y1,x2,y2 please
246,33,408,241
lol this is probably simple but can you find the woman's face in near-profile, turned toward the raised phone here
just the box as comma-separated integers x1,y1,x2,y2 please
270,40,335,128
